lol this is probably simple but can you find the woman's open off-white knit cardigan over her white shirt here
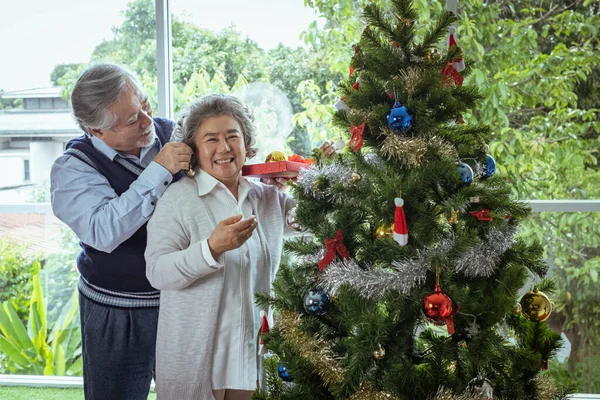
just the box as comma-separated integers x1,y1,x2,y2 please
145,176,295,400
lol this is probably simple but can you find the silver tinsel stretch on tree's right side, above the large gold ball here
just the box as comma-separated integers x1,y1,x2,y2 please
454,224,515,278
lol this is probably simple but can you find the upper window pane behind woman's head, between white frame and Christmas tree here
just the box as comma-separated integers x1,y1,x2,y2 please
173,0,340,159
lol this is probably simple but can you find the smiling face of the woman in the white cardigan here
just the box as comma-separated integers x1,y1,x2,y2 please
195,115,246,187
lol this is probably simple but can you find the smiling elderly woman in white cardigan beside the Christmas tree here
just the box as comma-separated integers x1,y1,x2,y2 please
145,95,294,400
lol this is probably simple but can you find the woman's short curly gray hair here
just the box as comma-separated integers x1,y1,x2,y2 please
176,94,257,169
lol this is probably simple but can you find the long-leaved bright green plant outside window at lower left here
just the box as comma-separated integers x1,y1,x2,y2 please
0,274,82,375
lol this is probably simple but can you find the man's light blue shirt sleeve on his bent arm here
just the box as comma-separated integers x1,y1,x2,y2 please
50,155,173,253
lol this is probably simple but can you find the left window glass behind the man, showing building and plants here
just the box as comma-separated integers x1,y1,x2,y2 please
0,0,156,378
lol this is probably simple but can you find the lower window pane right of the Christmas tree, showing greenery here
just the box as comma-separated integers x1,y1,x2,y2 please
521,212,600,394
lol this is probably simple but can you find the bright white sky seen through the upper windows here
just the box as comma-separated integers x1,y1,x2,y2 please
0,0,315,91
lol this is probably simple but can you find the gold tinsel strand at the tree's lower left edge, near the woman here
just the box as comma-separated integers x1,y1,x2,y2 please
278,311,344,385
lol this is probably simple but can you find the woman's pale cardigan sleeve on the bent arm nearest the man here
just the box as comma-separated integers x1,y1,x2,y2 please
145,192,223,290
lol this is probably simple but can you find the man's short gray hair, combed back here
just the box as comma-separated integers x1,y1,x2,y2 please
71,64,146,136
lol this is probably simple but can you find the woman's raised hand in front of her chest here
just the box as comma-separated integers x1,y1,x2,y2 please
208,215,258,260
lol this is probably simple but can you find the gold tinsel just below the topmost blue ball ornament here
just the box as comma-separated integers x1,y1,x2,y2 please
381,134,457,168
